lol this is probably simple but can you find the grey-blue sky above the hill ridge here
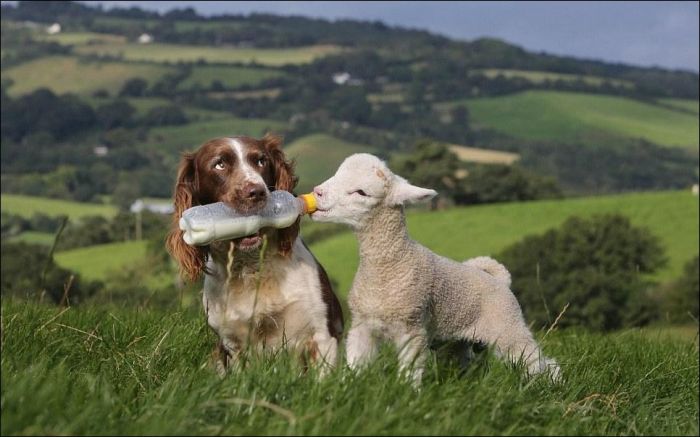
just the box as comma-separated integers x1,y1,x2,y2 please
83,1,700,72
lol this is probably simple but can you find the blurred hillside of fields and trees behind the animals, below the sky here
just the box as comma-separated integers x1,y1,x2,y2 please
1,2,699,330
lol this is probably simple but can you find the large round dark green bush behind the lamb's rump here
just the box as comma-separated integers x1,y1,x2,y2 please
498,215,666,331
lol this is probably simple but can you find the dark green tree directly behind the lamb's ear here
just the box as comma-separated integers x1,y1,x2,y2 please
391,140,460,209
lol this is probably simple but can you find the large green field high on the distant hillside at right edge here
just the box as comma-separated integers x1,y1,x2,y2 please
438,91,699,149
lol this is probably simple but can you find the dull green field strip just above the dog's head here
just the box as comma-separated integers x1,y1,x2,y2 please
147,116,286,159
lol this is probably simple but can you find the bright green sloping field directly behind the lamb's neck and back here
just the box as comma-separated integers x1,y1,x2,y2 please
311,191,698,296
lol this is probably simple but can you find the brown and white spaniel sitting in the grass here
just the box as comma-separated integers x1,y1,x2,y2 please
166,134,343,371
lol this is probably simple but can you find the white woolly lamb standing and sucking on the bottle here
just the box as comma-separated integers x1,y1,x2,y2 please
312,153,559,384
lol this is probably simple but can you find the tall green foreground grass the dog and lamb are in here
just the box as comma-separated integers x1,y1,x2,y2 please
1,299,698,435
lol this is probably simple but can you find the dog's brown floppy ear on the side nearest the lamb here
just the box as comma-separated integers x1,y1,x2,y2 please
260,133,299,256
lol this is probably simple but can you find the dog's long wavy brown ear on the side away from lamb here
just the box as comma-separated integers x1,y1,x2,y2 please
165,153,208,282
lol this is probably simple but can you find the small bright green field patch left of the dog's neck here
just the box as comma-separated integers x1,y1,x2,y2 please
55,241,149,280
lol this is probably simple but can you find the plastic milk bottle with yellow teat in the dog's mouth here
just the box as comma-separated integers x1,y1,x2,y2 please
179,190,316,246
